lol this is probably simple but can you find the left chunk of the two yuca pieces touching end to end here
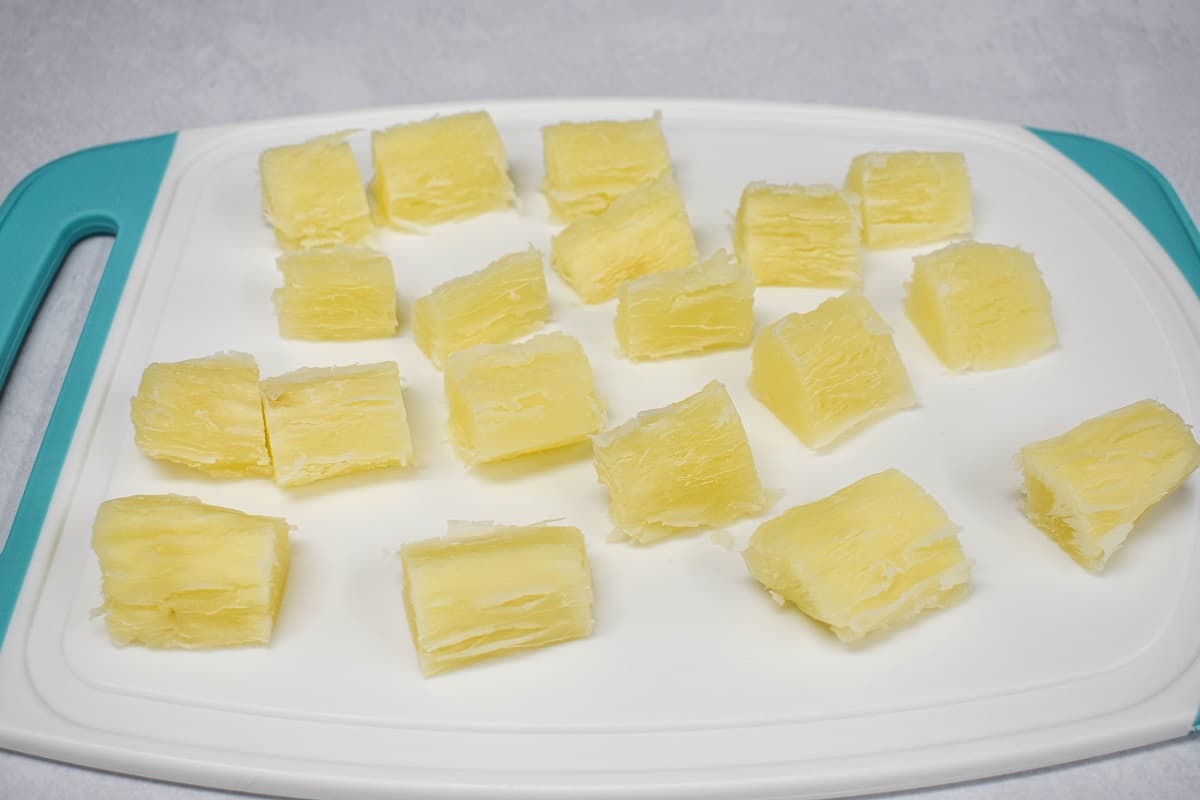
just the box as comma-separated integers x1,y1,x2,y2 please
131,353,271,477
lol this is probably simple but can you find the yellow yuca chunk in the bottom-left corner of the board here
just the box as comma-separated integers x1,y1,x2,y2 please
91,494,288,648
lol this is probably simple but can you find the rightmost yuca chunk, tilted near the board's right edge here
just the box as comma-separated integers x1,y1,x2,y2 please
1020,399,1200,572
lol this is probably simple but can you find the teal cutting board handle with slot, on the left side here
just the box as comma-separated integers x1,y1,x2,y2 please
0,133,175,644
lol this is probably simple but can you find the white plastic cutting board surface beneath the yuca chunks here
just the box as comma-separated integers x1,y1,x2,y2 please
0,101,1200,798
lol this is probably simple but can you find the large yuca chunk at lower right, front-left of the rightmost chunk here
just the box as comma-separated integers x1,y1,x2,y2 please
743,469,971,642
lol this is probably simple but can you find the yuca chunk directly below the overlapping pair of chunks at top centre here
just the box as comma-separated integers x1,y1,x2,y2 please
616,249,754,359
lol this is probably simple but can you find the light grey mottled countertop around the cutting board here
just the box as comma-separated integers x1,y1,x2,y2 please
0,0,1200,800
